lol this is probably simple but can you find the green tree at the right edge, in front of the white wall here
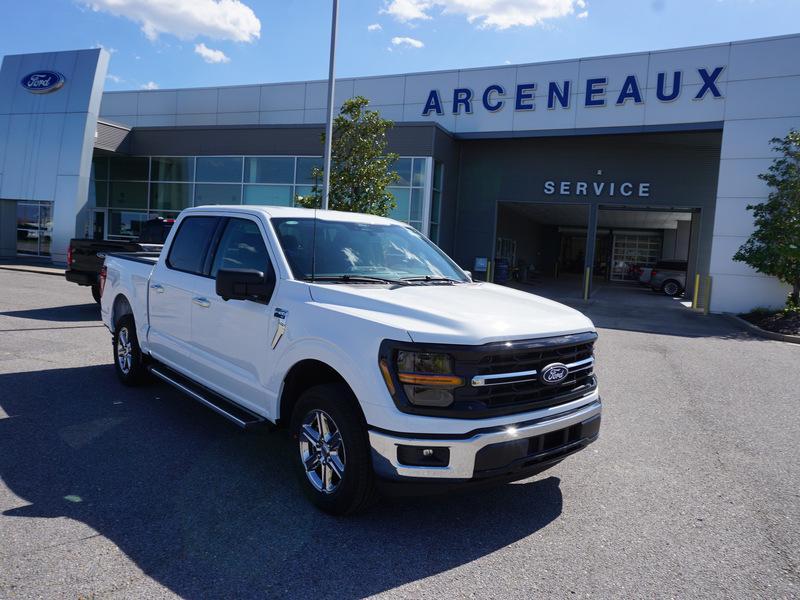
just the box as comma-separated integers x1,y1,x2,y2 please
733,129,800,307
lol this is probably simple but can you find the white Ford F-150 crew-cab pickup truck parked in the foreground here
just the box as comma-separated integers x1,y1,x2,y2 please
101,206,601,514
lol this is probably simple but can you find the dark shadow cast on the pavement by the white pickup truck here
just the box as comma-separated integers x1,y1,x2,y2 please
0,366,562,598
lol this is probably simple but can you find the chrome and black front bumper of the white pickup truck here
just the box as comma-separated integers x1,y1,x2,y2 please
369,397,602,482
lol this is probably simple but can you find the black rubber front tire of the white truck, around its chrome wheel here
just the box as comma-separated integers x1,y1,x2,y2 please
290,383,376,515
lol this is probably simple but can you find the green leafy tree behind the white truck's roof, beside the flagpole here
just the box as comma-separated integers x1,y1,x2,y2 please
296,96,398,217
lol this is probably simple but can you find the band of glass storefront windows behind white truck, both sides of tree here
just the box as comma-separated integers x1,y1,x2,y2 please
89,156,432,236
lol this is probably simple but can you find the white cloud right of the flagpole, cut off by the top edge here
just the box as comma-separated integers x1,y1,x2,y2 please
381,0,588,29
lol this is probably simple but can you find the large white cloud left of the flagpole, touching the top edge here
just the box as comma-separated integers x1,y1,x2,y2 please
84,0,261,42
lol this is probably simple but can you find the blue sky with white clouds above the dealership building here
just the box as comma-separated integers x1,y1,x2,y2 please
0,0,800,90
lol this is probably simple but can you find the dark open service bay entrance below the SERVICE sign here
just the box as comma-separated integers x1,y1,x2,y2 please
494,202,700,296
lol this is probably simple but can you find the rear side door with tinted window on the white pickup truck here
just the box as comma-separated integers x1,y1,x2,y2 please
147,215,221,370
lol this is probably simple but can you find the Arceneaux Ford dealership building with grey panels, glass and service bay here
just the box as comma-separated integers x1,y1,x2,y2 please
0,35,800,312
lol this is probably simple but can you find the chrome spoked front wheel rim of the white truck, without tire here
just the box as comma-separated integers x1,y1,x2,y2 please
299,409,346,494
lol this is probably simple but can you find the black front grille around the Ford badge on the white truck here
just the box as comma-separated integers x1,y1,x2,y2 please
455,335,597,414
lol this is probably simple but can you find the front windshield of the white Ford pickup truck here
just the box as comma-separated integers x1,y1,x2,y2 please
272,218,468,283
